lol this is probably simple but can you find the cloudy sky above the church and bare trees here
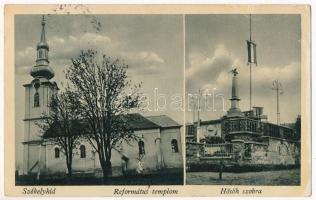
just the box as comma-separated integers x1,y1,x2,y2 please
15,15,184,167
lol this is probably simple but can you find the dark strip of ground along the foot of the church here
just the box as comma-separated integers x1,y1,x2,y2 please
16,171,183,186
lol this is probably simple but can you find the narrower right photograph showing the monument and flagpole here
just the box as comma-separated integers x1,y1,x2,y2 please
185,14,302,186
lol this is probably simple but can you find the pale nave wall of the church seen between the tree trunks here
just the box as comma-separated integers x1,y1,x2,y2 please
46,129,171,176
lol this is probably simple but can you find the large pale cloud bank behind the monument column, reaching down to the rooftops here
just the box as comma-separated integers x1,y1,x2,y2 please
186,43,301,122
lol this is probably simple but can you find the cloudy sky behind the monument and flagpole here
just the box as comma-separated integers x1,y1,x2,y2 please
185,15,301,122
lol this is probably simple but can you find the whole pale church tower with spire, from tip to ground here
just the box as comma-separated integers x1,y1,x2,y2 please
23,16,58,174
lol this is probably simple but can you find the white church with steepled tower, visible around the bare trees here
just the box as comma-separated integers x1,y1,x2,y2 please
19,19,183,176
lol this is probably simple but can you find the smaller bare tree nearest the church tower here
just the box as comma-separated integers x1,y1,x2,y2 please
36,89,85,177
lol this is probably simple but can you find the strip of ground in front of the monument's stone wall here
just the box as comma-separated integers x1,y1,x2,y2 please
186,169,300,186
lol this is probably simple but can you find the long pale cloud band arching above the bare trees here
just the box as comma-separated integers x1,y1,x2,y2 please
16,32,165,74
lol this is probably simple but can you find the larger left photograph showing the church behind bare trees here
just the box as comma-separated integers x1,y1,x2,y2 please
12,14,185,186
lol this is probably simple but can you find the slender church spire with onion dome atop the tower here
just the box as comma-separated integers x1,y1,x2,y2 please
31,16,54,80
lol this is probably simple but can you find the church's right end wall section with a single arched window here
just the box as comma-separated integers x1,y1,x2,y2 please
161,128,183,168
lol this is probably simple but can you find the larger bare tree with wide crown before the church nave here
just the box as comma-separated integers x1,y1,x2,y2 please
66,50,141,178
